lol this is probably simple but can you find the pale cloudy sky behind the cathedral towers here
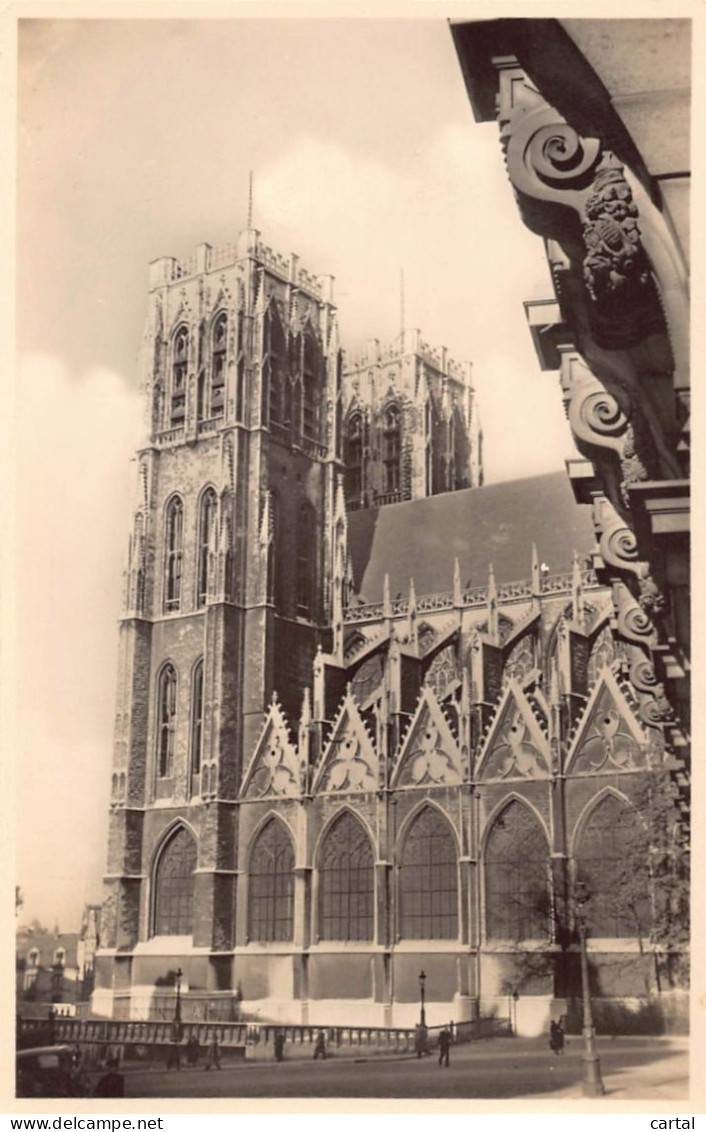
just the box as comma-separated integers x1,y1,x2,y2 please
16,18,572,929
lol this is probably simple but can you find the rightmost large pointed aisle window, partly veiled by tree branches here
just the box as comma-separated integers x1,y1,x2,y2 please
576,795,652,940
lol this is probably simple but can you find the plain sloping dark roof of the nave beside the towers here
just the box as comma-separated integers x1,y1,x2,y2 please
348,471,594,601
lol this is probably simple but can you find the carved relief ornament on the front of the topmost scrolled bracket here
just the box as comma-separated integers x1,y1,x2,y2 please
584,152,649,302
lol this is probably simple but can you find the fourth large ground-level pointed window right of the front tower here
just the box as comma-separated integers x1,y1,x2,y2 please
485,801,551,942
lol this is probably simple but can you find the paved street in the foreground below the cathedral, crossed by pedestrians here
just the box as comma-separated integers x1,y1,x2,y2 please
126,1038,688,1101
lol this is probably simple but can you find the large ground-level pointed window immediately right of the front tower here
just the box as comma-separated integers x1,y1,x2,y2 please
248,818,294,943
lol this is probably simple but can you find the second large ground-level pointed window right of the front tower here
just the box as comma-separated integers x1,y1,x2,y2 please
319,813,374,940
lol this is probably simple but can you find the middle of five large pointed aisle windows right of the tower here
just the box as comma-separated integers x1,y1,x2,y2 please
399,807,458,940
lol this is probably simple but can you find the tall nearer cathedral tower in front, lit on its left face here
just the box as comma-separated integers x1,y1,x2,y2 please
94,229,341,1017
